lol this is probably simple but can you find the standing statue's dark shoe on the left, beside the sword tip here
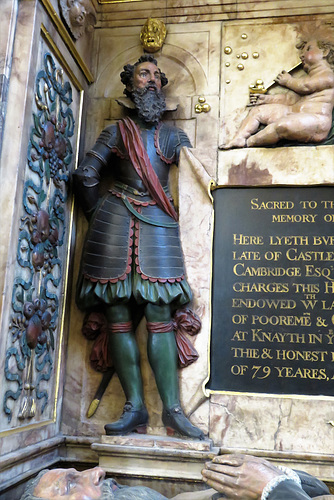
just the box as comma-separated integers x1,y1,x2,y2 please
104,401,148,436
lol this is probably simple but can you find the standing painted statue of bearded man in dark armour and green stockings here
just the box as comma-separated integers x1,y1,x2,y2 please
74,55,203,439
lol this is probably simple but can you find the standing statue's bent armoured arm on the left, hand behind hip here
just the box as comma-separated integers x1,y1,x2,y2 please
73,125,117,219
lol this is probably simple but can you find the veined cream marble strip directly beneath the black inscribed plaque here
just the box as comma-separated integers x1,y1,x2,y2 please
210,394,334,481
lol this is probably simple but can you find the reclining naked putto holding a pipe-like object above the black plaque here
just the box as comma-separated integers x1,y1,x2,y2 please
219,23,334,149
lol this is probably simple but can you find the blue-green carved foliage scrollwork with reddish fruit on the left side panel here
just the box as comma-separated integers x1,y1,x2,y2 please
3,53,74,421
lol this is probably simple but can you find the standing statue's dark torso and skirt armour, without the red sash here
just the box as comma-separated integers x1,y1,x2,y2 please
77,119,191,284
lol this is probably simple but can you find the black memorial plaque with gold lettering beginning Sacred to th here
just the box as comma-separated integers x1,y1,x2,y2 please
207,187,334,396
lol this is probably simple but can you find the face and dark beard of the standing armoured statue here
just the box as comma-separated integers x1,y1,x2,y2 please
131,62,166,123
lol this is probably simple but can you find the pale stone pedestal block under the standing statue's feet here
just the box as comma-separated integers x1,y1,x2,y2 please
92,434,219,481
